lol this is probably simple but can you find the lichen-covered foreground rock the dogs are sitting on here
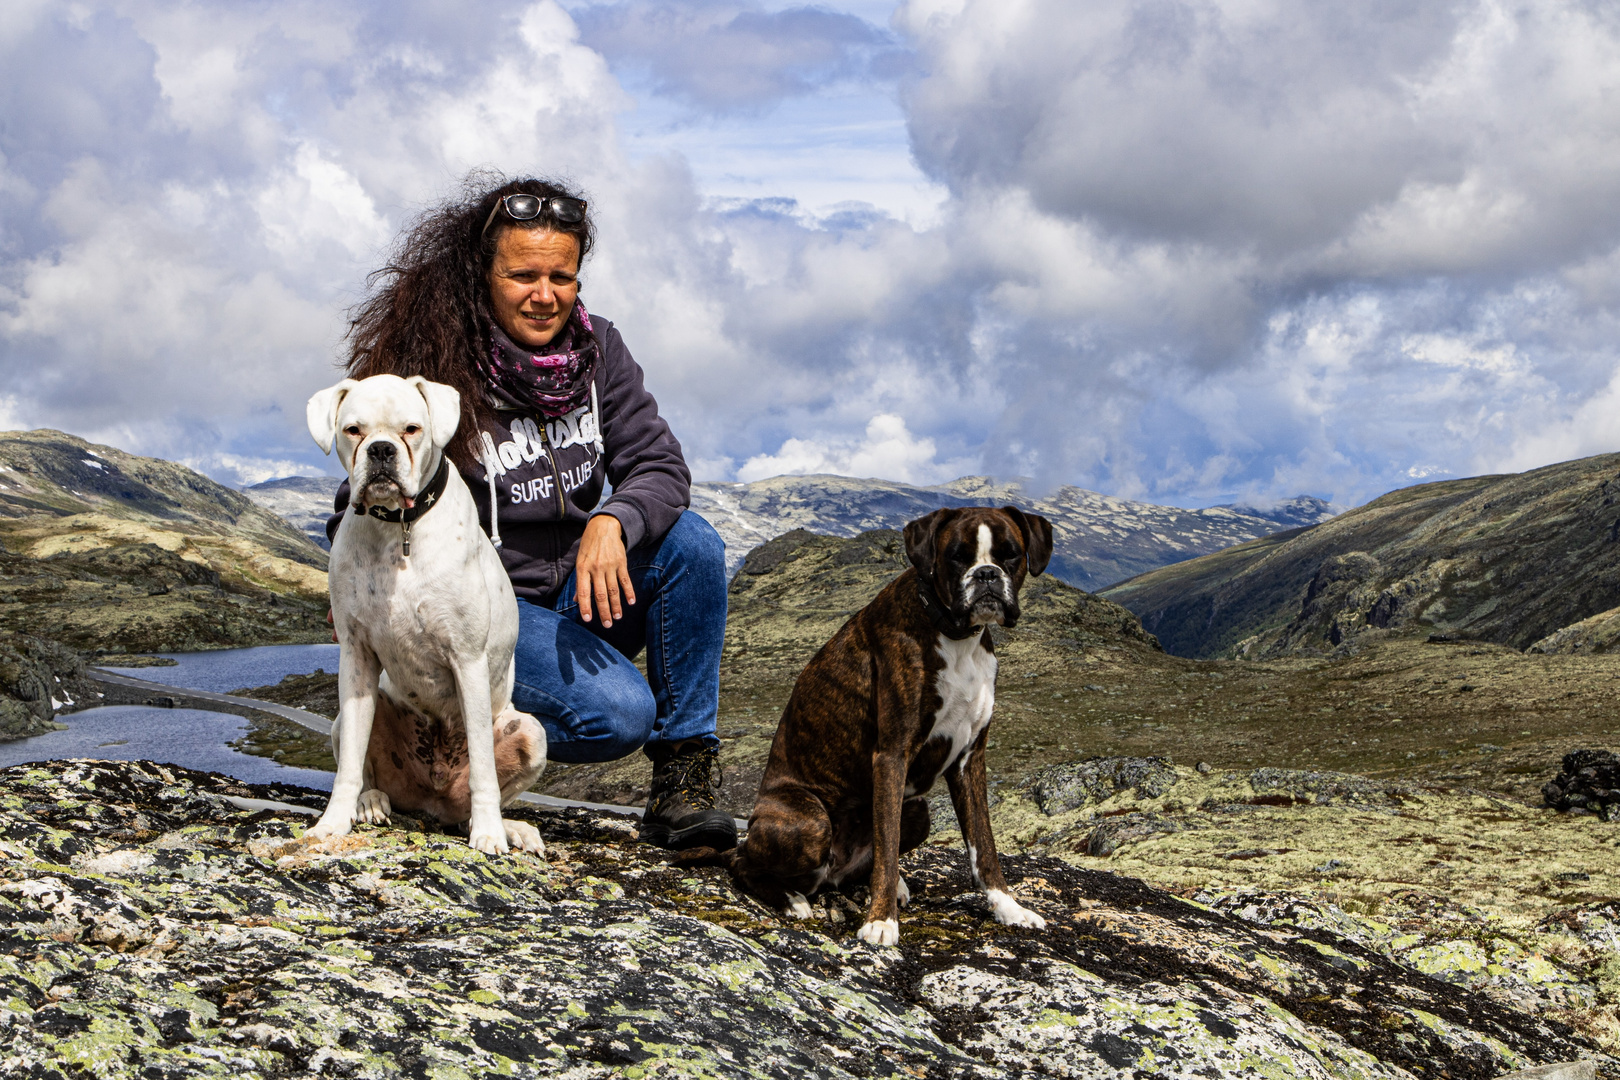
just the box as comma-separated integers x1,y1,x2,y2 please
0,763,1615,1080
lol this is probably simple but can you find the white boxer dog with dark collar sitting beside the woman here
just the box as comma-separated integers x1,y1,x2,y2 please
306,376,546,853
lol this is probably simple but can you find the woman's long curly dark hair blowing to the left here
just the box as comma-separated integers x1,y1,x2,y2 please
347,170,596,466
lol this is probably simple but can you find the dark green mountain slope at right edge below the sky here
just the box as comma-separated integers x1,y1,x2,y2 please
1103,453,1620,659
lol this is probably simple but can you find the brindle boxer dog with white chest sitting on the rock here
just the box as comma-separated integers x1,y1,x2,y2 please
729,507,1051,944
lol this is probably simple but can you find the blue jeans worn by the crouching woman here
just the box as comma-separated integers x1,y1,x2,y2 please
512,510,726,764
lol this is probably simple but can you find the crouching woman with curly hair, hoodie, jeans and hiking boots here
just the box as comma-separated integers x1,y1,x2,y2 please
327,173,737,848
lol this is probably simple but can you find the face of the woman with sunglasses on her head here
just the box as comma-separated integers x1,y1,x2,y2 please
489,228,580,350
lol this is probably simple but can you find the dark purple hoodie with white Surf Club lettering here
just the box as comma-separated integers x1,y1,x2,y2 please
326,314,692,606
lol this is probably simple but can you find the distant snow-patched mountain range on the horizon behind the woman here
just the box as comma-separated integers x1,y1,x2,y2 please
243,476,1337,591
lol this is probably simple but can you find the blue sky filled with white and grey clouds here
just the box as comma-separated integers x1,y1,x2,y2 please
0,0,1620,505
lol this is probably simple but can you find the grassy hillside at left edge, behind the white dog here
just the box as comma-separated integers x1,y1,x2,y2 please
0,431,330,738
